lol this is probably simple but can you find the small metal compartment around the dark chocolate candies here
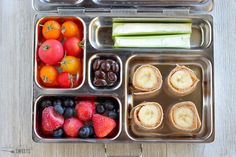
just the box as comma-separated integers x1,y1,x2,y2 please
88,53,123,91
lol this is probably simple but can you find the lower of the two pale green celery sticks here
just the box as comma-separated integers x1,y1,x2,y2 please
114,34,191,48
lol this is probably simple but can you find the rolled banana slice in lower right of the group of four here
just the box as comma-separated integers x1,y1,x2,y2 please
169,101,201,132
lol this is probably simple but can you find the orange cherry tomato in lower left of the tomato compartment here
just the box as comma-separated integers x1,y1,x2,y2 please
39,65,58,84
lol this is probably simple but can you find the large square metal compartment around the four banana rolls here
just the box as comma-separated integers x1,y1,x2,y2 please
124,52,213,141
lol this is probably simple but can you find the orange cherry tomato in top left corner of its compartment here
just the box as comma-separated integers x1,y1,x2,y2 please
42,20,61,39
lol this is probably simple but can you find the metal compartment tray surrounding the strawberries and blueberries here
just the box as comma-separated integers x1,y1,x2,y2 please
33,94,122,142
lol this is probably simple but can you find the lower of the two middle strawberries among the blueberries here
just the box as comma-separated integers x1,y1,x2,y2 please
63,117,84,137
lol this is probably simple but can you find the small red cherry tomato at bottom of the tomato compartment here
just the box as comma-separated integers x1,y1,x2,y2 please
57,72,74,88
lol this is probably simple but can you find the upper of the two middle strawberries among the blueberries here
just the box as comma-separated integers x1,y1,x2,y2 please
75,100,95,121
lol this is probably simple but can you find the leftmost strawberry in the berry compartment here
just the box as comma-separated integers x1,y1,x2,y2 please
42,106,64,132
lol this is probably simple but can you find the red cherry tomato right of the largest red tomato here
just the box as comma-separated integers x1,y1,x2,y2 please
63,37,83,57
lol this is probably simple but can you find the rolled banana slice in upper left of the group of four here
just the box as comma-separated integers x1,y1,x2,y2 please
132,65,163,92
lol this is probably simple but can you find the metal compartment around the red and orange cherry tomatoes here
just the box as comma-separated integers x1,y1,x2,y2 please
34,16,86,90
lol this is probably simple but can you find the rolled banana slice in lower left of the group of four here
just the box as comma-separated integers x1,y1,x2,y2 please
131,102,163,129
